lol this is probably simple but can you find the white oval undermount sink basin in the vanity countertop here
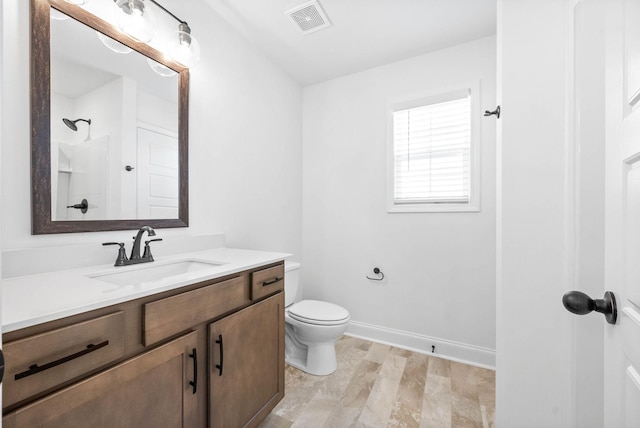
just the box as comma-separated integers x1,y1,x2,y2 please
88,260,223,285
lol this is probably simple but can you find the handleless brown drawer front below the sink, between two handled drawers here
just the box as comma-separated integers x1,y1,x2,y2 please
142,277,245,346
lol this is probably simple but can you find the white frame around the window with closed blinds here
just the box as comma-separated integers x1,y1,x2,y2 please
387,81,481,213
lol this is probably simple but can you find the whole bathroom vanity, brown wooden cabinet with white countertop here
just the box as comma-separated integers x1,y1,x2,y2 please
2,248,287,428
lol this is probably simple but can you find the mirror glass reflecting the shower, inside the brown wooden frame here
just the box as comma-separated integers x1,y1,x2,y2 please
50,10,178,221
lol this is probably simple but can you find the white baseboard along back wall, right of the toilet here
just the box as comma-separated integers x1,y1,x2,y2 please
345,321,496,370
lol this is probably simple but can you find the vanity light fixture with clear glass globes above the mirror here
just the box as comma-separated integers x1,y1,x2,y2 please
114,0,200,68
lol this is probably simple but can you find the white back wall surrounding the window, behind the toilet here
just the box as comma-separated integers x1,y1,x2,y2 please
302,37,496,366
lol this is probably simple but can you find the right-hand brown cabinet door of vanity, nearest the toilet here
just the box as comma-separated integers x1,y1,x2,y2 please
209,293,284,428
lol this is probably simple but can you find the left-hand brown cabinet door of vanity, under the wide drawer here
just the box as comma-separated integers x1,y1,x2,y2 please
3,332,197,428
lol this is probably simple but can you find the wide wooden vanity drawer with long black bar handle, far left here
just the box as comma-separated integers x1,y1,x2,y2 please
2,312,124,407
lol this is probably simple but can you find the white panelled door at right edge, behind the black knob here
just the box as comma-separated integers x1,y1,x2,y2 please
604,0,640,427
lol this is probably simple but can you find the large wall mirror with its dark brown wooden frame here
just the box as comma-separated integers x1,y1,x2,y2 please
31,0,189,235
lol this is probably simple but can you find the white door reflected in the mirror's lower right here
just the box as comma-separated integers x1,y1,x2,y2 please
136,128,179,218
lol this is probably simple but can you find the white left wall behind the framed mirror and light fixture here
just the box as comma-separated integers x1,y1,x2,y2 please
1,0,302,255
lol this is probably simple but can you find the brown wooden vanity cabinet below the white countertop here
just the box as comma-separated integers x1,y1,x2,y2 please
2,262,284,428
